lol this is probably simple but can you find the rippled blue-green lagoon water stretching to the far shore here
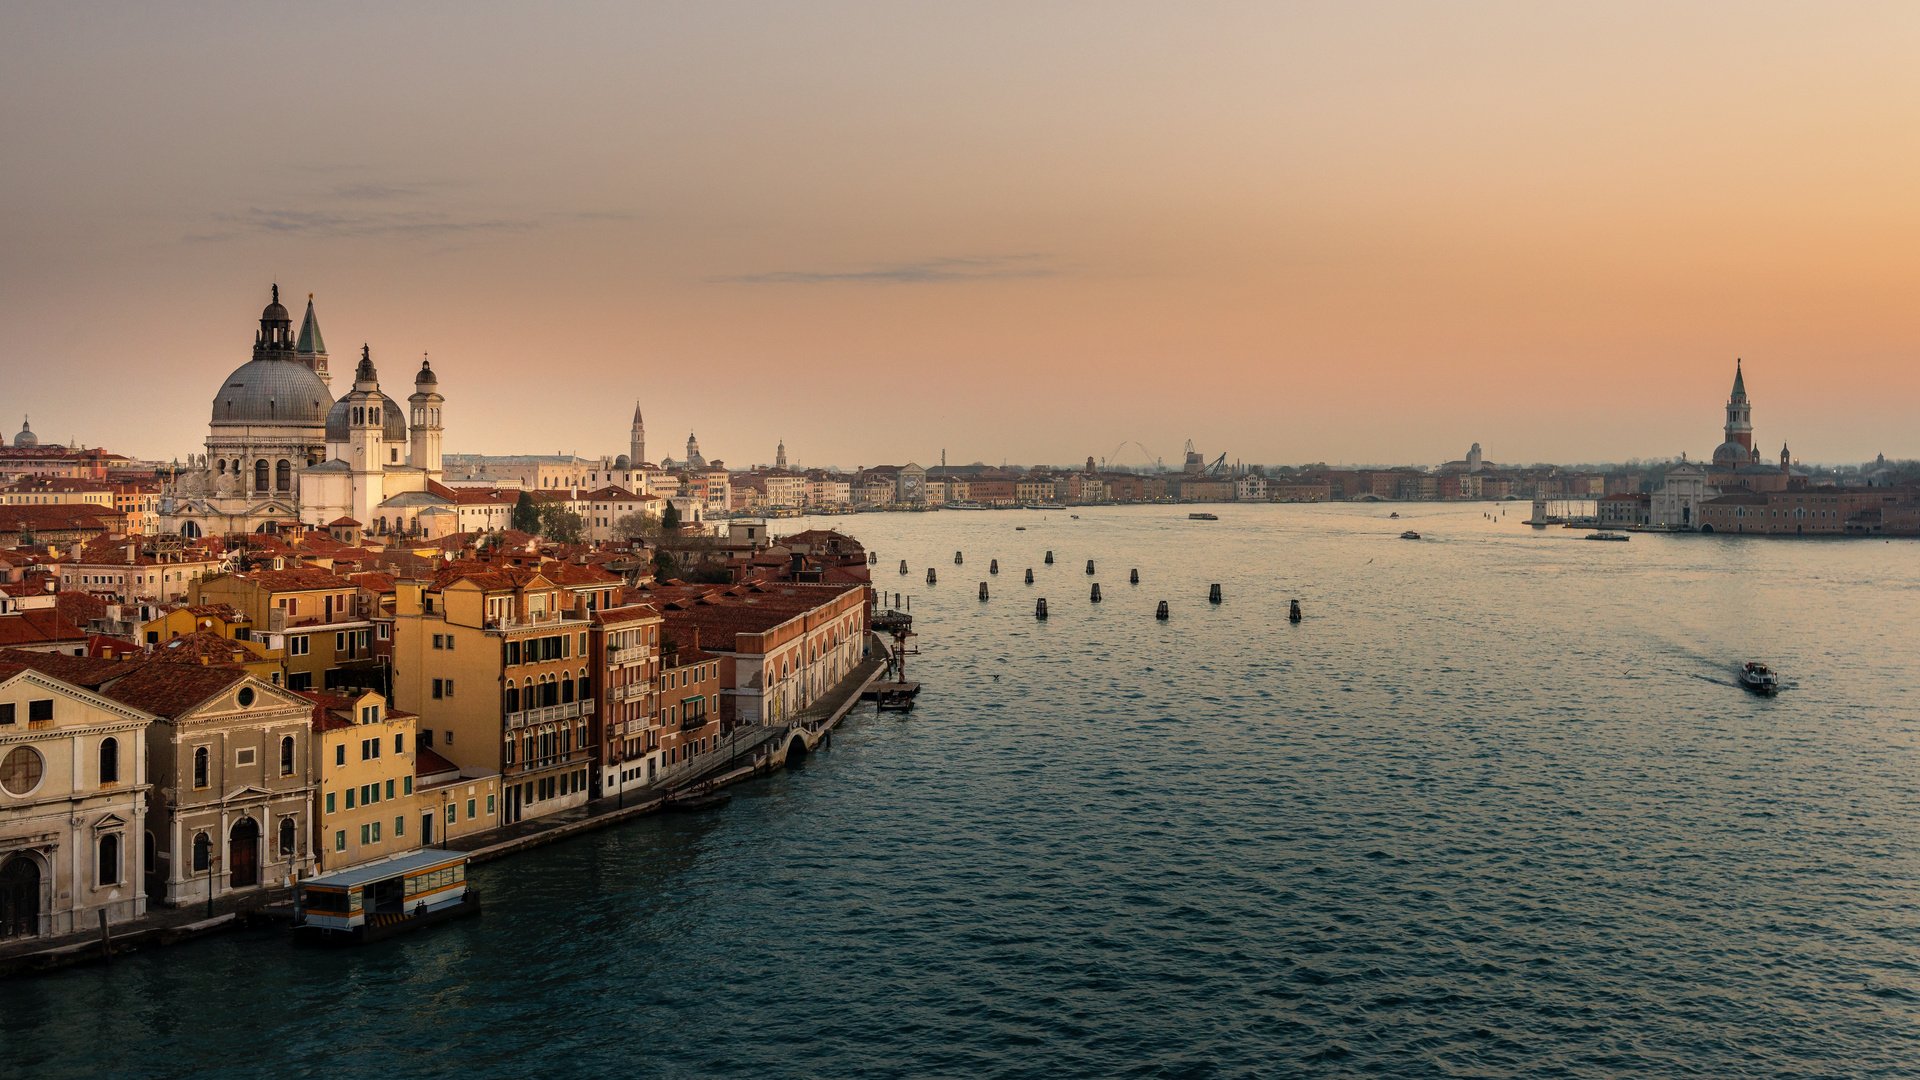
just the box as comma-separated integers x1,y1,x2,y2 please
0,503,1920,1078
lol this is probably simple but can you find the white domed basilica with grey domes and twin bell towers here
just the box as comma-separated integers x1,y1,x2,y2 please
161,284,455,536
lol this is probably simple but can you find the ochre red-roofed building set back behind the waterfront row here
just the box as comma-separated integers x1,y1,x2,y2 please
190,567,378,690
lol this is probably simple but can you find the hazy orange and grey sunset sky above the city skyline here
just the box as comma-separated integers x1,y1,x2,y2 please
0,0,1920,467
